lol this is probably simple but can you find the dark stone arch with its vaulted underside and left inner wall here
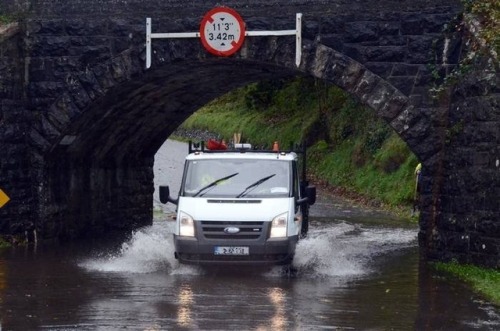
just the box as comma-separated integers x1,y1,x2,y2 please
31,38,430,241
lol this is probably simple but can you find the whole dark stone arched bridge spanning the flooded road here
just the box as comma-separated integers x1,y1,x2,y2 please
0,0,500,267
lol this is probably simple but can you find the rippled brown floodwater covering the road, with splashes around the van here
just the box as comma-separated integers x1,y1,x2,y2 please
0,142,500,330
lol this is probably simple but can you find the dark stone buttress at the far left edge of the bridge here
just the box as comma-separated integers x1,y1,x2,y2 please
0,24,37,234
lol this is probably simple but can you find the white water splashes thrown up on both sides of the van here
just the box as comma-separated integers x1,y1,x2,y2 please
80,221,416,278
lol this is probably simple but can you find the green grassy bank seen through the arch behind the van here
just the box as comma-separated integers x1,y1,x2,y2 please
183,78,418,214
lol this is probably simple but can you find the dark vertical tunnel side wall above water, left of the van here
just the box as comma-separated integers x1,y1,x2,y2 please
38,159,154,240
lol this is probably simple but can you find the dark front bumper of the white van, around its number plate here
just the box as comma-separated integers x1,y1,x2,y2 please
174,235,298,266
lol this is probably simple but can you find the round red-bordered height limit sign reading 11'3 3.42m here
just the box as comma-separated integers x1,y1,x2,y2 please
200,7,245,56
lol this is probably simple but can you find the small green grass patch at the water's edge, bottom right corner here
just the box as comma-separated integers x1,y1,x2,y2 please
432,262,500,306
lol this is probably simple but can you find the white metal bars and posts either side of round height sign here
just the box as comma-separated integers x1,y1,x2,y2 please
146,13,302,69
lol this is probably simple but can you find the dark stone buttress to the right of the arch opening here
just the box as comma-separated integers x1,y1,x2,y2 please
429,58,500,267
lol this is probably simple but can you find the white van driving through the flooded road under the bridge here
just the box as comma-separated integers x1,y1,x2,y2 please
160,143,316,265
